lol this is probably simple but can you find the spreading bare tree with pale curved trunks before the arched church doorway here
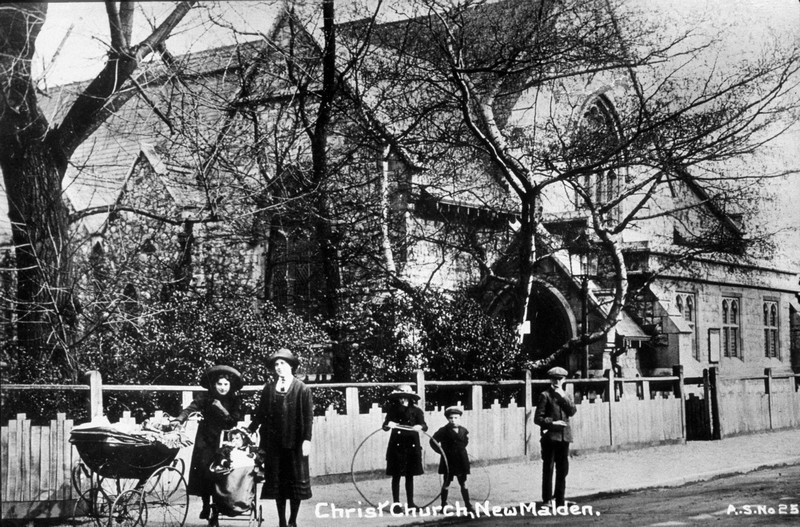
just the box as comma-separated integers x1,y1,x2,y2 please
338,0,800,367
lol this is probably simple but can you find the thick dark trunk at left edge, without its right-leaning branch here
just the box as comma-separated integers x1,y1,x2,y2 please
0,3,77,375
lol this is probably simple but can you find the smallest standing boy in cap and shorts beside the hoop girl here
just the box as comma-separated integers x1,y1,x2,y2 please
431,406,473,512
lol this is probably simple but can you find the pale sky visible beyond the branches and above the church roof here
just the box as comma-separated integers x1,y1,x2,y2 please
10,0,800,263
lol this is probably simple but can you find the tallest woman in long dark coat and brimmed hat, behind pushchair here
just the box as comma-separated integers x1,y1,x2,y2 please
250,349,314,527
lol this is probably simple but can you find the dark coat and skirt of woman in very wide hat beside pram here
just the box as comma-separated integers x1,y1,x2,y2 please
176,390,242,496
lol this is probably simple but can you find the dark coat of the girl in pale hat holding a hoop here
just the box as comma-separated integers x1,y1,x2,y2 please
383,403,428,476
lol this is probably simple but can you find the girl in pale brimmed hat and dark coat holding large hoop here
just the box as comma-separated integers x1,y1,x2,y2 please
383,384,428,508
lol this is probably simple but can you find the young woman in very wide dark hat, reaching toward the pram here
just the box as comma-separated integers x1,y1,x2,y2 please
175,365,242,520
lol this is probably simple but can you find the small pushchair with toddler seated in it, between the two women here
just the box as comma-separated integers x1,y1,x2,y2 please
208,428,264,527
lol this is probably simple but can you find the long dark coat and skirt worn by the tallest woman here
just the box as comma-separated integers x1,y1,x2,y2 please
250,379,314,500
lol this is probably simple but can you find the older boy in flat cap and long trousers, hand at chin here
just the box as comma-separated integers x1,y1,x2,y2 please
533,367,577,507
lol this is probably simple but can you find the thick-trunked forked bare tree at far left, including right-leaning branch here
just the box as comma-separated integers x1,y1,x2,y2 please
0,2,194,375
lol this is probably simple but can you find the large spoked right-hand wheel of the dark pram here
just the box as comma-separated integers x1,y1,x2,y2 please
142,466,189,527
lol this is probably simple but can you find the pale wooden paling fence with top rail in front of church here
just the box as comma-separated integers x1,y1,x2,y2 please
0,367,800,518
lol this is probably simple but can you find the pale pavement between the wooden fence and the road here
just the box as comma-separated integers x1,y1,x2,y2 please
185,429,800,527
